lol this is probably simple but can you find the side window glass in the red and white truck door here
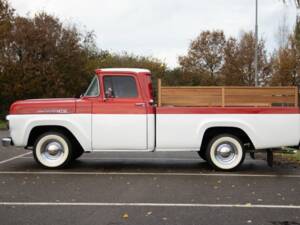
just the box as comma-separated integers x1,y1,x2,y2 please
104,76,138,98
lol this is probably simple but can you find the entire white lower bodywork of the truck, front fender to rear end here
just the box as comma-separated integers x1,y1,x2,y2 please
8,114,300,151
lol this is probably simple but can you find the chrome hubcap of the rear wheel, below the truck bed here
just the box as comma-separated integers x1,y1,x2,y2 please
215,143,237,164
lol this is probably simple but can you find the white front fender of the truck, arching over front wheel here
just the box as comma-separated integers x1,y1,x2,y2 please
8,114,92,151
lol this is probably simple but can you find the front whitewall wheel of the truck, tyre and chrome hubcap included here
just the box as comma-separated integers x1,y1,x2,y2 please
33,132,73,168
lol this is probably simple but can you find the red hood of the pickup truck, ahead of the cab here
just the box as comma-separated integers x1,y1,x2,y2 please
9,98,76,115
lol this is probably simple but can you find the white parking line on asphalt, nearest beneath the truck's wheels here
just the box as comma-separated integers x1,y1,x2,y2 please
0,171,300,178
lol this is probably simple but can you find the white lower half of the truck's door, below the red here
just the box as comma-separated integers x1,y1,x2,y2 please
92,114,147,151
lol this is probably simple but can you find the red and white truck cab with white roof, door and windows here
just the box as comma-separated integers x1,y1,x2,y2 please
81,69,154,151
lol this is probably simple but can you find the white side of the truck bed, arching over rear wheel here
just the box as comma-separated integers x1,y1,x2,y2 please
157,114,300,151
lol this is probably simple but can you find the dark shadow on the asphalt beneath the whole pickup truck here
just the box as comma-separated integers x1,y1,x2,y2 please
0,158,300,174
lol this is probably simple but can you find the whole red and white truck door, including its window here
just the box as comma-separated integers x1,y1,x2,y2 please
92,74,148,151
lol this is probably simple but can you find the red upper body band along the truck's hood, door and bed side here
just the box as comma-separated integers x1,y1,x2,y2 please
10,98,300,115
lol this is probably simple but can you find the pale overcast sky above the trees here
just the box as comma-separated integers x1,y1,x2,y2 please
10,0,297,68
